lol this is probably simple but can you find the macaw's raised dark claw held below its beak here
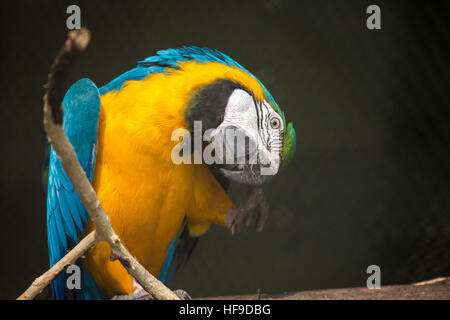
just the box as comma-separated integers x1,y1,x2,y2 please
225,186,269,234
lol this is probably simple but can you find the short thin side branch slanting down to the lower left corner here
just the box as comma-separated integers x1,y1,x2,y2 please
17,231,95,300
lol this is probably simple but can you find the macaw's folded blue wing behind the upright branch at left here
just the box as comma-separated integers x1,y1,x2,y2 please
47,79,100,299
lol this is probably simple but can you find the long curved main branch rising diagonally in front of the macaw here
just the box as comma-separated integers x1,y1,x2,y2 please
21,28,179,300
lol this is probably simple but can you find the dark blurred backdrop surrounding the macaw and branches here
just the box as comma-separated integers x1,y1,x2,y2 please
0,0,450,299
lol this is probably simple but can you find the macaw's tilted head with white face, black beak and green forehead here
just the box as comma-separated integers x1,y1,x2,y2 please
174,47,296,186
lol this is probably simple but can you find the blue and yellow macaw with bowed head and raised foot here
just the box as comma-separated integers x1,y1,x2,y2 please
47,47,296,299
